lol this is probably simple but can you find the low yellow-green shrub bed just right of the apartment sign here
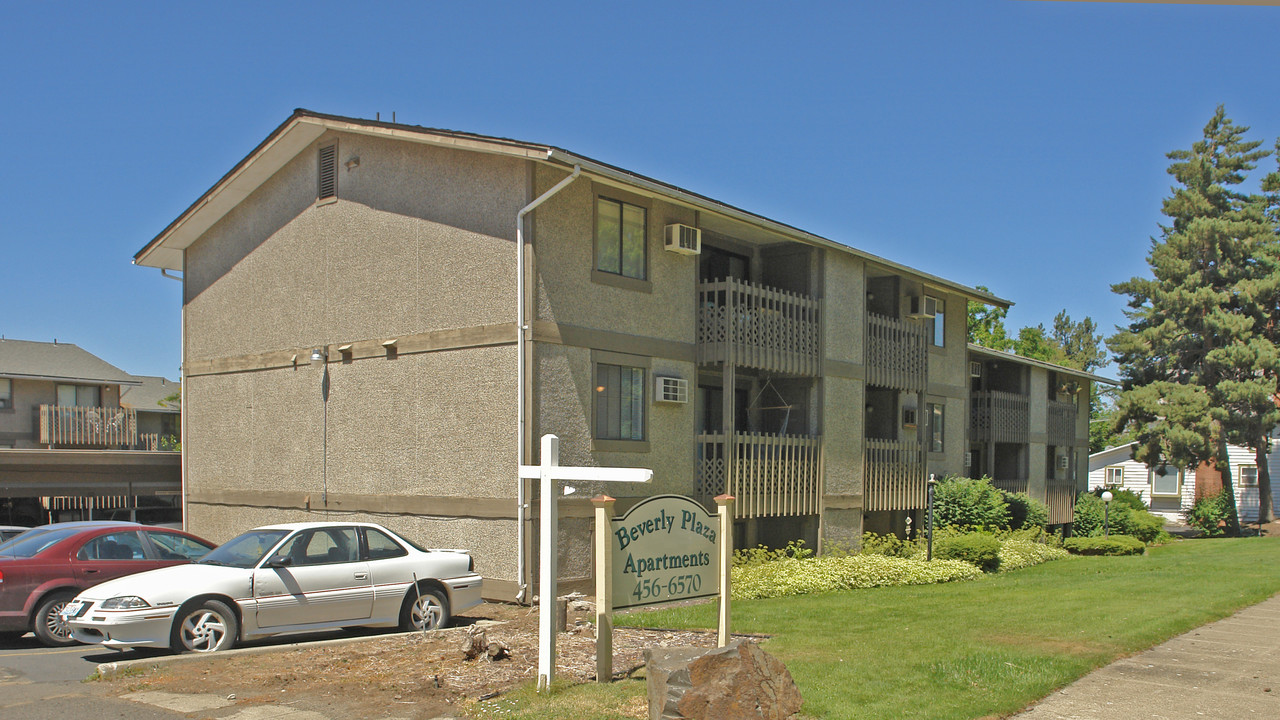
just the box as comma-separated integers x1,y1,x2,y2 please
732,555,982,600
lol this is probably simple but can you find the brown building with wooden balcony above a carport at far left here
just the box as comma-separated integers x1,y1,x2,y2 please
0,338,182,524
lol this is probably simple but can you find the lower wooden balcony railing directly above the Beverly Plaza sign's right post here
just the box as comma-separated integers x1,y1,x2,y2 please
698,433,822,519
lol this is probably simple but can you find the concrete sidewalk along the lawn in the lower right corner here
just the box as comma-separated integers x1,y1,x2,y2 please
1014,591,1280,720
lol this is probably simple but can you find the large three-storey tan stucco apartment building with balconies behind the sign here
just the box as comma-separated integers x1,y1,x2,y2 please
134,110,1094,600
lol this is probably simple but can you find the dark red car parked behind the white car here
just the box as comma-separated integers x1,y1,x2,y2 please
0,523,215,646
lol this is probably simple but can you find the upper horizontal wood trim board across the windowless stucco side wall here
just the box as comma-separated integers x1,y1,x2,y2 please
187,323,516,377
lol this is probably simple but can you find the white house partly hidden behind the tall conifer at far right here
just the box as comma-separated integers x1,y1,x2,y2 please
1089,443,1280,523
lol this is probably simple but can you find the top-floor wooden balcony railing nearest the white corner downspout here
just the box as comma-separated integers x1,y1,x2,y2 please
698,278,819,375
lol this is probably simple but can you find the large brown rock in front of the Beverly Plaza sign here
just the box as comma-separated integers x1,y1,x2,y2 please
644,641,801,720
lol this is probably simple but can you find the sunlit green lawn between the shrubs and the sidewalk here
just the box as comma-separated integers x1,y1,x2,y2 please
473,538,1280,720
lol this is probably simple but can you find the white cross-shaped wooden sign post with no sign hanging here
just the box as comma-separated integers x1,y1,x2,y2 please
520,434,653,692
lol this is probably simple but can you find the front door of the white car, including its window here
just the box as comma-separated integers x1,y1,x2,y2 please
253,527,374,628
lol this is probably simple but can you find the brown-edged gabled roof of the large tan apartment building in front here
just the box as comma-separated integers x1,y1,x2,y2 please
133,109,1012,307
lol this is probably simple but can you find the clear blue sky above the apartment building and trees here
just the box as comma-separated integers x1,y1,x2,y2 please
0,0,1280,378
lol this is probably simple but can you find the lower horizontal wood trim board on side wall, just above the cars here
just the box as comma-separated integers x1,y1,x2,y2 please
187,489,516,520
